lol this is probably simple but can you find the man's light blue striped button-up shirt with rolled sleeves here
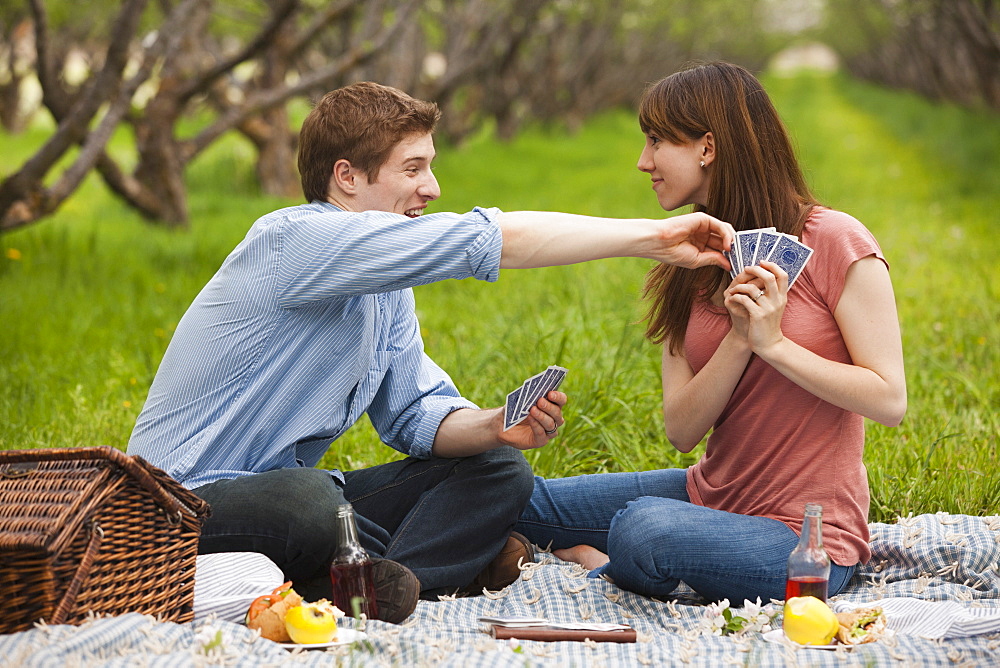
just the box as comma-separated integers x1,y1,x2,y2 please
128,202,502,488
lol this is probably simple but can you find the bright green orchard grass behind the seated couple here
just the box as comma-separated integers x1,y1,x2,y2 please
0,76,1000,521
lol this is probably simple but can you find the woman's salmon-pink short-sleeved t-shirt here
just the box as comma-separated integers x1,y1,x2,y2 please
684,207,888,566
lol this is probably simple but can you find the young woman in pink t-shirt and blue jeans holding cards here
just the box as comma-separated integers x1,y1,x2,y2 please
517,63,906,601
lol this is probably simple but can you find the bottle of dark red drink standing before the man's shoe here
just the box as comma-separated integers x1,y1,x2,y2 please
330,503,378,619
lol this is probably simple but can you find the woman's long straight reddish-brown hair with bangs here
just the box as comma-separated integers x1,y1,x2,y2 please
639,62,817,354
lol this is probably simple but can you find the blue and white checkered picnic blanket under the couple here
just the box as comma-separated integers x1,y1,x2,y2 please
0,513,1000,668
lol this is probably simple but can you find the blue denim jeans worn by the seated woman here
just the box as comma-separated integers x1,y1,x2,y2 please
515,469,854,605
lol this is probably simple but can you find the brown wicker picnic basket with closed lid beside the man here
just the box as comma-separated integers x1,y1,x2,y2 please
0,447,209,633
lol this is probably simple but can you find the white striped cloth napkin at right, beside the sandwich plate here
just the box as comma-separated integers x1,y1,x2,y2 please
833,597,1000,638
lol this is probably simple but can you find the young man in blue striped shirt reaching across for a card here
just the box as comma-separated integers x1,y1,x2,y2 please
128,83,733,622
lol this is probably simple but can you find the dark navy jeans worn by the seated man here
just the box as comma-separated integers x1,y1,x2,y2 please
193,446,533,600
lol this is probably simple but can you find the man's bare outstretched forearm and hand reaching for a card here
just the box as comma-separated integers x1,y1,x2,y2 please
498,211,736,269
